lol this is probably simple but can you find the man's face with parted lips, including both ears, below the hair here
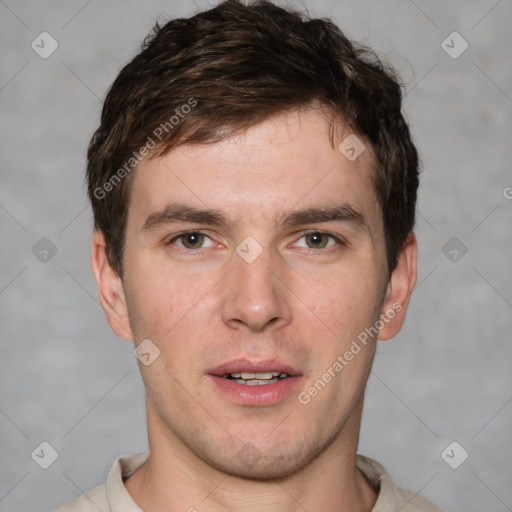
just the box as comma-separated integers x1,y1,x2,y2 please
93,111,415,478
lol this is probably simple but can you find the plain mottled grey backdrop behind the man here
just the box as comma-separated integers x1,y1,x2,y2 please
0,0,512,512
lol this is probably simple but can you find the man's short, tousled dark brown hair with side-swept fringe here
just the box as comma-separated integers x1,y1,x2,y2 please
87,0,419,277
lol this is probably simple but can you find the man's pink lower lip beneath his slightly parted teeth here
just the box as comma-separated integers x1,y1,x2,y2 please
208,375,302,407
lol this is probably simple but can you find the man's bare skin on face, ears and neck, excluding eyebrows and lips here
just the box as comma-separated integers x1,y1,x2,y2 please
92,109,417,512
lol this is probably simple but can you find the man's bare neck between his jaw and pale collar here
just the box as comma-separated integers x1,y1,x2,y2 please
125,401,377,512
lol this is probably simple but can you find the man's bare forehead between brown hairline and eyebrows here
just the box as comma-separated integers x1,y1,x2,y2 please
130,110,378,226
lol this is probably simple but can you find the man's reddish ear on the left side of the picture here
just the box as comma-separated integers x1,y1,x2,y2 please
91,231,133,340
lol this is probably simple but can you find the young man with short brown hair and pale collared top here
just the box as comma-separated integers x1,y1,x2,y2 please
59,0,444,512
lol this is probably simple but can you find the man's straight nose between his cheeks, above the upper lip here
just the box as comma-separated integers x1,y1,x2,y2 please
222,249,292,332
